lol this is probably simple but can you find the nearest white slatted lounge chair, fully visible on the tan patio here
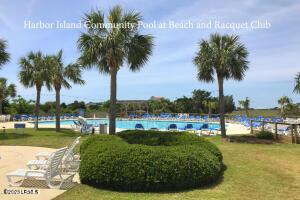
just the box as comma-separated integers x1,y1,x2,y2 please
6,147,75,189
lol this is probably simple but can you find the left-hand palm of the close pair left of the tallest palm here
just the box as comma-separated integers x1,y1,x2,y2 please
19,51,51,129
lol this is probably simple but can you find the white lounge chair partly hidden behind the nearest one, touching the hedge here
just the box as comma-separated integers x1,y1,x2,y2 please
27,137,80,172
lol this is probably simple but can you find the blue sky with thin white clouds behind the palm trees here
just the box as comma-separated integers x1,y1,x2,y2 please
0,0,300,108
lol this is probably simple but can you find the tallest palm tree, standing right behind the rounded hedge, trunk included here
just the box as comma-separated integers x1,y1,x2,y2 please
78,6,153,134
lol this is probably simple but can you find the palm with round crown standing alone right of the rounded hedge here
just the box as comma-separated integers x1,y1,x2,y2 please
194,33,248,137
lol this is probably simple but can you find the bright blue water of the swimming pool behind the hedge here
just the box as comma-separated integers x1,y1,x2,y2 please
39,119,220,129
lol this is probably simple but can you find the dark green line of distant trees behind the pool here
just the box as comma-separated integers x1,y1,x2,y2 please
3,90,236,116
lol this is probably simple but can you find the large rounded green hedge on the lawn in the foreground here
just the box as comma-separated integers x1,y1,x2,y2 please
79,131,222,191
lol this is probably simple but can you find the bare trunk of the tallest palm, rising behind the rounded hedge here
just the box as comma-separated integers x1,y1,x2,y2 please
109,67,117,135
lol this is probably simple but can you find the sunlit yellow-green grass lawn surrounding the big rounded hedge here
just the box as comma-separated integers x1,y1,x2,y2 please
0,129,300,200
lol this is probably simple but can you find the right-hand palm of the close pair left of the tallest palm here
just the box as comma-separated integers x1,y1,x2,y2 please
47,50,84,131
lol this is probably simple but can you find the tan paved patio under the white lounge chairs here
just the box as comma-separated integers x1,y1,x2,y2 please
0,146,79,200
